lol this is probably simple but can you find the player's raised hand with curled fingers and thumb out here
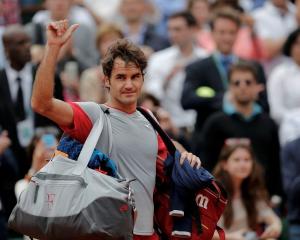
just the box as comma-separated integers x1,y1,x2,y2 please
47,20,79,47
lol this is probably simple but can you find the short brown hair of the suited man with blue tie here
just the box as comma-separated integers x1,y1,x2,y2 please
210,7,241,30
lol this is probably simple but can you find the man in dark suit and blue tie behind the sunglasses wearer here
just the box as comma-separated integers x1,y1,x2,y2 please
181,7,268,156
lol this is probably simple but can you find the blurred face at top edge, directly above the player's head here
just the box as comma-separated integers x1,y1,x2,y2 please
121,0,146,22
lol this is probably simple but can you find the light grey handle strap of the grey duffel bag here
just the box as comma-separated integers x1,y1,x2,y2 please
72,105,104,175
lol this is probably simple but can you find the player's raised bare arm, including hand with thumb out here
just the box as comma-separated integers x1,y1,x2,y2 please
31,20,78,127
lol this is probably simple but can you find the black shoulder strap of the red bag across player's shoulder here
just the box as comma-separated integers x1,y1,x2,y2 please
137,107,176,156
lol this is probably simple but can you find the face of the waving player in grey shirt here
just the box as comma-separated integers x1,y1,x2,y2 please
105,58,144,108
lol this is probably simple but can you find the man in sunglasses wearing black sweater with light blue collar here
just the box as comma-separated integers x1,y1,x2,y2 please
202,61,282,199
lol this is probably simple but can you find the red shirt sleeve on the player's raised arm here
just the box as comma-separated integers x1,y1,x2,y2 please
60,102,93,143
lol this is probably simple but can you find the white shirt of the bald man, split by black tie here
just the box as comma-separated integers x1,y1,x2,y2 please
5,63,33,113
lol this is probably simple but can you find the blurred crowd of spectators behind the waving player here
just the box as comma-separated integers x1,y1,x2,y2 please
0,0,300,240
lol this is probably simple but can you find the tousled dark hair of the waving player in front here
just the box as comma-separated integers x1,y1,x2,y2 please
102,39,147,78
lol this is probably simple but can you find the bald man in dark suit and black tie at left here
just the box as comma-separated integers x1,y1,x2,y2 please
0,25,63,177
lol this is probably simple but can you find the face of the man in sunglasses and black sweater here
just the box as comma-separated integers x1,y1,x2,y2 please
229,70,263,105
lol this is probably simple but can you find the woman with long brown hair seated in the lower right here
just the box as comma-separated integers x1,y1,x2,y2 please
214,139,282,240
